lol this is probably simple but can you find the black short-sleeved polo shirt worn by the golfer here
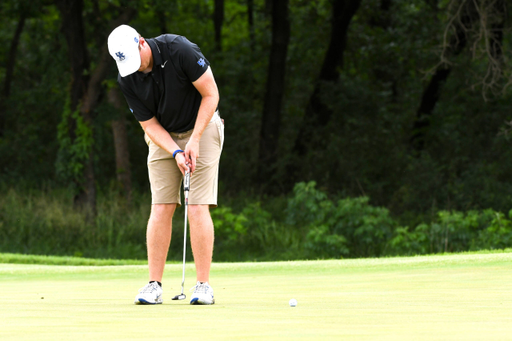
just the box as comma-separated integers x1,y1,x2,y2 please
117,34,210,133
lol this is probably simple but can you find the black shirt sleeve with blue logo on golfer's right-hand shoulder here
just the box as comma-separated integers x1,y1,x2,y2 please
176,36,210,82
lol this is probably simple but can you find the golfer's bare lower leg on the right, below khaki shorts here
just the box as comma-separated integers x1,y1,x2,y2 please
188,205,214,282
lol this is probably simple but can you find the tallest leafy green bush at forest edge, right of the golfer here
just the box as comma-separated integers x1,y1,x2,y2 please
287,182,395,258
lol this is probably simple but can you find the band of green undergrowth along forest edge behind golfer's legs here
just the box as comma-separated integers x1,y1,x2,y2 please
0,182,512,261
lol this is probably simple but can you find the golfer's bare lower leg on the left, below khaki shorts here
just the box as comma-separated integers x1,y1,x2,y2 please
146,204,176,282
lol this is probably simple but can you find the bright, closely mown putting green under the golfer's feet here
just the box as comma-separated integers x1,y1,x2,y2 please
0,252,512,340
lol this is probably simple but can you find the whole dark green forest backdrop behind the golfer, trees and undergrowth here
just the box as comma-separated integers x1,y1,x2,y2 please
0,0,512,261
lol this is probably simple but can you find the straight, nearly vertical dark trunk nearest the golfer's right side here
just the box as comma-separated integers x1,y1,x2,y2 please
258,0,290,183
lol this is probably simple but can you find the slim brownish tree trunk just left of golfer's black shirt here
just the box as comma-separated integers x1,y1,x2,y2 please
108,86,132,202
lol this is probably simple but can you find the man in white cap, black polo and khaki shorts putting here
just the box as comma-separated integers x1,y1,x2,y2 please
108,25,224,304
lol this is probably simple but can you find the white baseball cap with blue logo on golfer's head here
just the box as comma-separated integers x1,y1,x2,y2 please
108,25,140,77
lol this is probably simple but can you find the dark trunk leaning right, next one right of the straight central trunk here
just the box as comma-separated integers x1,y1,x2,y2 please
293,0,361,156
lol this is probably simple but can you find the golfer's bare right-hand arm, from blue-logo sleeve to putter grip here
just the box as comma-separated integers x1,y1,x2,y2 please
185,66,219,172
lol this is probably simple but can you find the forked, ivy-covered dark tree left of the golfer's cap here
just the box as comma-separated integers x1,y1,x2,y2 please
55,0,135,214
